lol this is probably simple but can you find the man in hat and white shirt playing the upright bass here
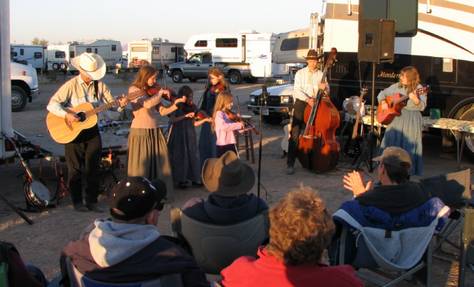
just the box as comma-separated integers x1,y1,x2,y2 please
286,49,328,174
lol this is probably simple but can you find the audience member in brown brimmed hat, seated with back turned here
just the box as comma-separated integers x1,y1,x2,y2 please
183,151,268,225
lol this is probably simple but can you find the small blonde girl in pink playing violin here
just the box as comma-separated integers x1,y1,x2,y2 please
212,92,244,157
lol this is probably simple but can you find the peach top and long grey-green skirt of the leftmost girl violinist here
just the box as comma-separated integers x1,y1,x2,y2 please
128,86,173,196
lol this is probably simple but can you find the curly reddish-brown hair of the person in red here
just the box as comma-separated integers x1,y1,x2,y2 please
267,187,335,265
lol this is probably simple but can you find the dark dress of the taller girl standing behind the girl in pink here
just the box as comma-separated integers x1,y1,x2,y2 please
199,88,217,168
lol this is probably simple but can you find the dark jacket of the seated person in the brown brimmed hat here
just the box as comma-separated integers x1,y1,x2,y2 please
183,194,268,225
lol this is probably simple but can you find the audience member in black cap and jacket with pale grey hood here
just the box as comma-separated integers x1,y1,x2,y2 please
61,177,209,286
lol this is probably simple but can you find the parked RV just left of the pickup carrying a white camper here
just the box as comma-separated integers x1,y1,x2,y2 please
128,38,184,70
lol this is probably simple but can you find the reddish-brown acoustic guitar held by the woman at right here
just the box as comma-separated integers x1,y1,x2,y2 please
377,86,429,125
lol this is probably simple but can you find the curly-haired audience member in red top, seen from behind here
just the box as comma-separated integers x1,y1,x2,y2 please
221,188,363,287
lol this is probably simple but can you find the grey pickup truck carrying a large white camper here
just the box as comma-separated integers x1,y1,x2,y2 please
169,32,281,84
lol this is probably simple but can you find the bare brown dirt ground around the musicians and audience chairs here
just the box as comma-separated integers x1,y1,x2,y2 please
0,75,474,286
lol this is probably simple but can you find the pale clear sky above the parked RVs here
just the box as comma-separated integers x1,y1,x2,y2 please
10,0,323,45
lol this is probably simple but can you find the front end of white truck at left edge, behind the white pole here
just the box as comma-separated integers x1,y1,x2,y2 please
10,62,39,112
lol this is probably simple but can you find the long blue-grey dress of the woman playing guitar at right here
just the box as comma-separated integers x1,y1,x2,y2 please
377,83,427,176
